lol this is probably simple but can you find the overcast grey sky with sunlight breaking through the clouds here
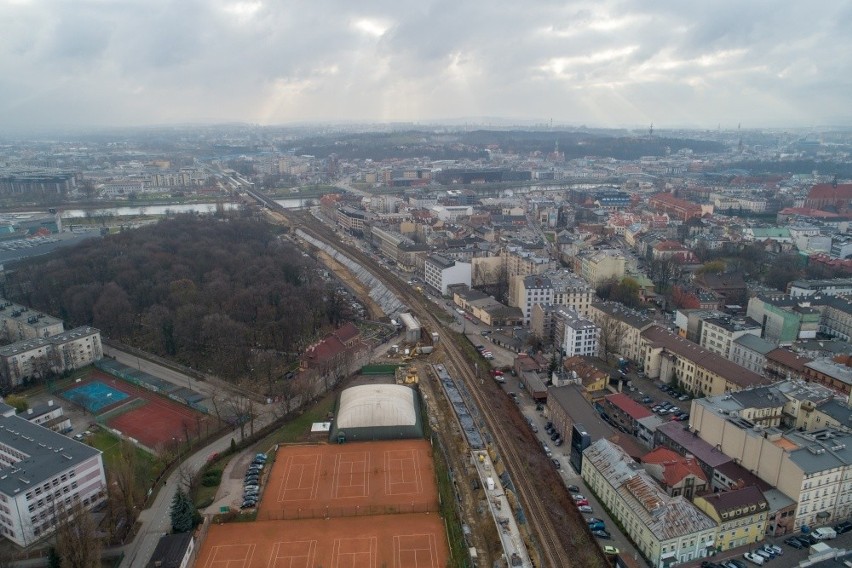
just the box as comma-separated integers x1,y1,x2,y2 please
0,0,852,130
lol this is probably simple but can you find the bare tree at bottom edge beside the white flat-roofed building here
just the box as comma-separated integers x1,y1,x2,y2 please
54,500,101,568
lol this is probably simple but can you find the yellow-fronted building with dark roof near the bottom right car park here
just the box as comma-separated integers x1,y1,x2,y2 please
693,486,769,552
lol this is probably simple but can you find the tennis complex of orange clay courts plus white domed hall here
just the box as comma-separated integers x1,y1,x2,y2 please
196,385,449,568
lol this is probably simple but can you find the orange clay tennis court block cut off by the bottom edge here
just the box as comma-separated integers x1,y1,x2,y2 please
195,513,449,568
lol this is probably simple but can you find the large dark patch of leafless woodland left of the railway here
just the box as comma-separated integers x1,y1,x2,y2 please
3,215,332,379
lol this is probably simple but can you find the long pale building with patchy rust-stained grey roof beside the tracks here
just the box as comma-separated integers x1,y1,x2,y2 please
582,439,718,568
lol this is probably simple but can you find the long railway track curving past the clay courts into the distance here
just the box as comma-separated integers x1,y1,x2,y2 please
255,200,576,568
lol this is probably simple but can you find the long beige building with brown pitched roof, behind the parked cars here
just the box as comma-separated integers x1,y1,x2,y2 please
639,325,771,396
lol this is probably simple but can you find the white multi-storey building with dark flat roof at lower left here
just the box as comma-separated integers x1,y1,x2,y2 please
0,403,106,547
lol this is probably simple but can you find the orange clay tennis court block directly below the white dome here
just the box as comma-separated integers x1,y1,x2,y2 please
257,440,438,520
